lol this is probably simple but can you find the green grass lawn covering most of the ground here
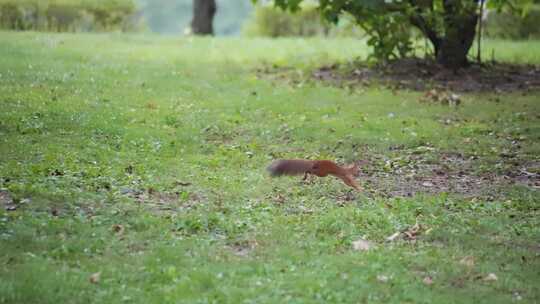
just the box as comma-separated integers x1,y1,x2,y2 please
0,33,540,303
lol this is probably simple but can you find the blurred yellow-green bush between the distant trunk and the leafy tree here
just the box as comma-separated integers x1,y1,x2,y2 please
243,5,363,37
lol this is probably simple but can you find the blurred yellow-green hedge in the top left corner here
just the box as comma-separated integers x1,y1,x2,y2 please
0,0,142,32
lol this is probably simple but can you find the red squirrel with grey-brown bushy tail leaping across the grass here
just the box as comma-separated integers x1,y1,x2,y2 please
267,159,360,191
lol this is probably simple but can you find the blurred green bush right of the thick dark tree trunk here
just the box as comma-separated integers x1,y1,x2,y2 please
486,5,540,39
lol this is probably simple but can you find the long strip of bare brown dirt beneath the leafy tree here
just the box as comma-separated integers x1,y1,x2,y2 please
257,58,540,93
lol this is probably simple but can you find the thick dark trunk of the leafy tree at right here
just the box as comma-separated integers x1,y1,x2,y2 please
434,0,478,69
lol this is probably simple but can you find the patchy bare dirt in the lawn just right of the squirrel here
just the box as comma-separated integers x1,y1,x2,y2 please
359,151,540,200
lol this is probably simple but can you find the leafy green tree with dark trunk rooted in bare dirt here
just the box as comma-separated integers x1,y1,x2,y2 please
254,0,532,65
